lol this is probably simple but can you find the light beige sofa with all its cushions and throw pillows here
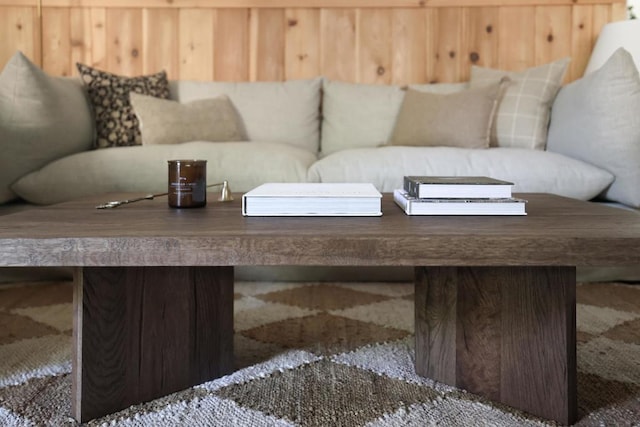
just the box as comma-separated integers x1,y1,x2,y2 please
0,49,640,282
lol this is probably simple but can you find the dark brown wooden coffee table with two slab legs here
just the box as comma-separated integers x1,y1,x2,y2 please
0,194,640,424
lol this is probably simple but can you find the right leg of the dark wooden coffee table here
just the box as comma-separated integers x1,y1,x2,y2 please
415,267,577,424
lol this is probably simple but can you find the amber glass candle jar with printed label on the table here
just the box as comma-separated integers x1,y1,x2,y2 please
167,160,207,208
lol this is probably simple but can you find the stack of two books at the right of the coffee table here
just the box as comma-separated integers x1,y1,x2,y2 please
393,176,527,215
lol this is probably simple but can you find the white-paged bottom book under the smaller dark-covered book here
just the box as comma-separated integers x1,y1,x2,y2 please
393,190,527,215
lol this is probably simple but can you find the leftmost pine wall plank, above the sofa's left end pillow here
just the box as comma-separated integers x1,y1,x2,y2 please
0,7,41,68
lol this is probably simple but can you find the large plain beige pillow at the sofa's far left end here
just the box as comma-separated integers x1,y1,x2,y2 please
0,52,93,203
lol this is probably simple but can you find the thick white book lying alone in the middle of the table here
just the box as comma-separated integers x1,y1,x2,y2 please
242,183,382,216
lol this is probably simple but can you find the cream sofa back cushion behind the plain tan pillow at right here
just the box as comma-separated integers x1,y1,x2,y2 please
320,79,467,155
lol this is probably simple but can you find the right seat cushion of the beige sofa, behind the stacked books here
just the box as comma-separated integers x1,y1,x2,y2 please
308,147,613,200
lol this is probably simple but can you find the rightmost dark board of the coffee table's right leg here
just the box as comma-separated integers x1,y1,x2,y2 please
500,267,577,424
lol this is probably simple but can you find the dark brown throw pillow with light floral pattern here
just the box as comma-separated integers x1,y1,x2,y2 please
76,64,169,148
